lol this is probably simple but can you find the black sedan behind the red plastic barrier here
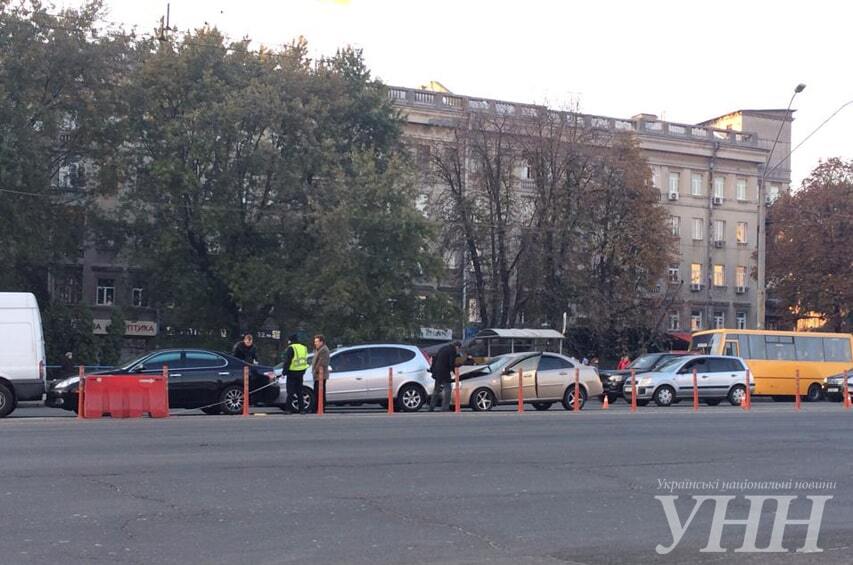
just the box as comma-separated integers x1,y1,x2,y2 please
46,349,279,414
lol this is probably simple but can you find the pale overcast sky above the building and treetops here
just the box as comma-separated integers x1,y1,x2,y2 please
68,0,853,186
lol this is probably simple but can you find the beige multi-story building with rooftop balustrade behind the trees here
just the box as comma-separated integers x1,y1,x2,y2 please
389,87,792,332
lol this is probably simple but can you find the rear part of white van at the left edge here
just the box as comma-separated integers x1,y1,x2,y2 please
0,292,46,418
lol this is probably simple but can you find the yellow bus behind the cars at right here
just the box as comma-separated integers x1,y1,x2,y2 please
690,330,853,400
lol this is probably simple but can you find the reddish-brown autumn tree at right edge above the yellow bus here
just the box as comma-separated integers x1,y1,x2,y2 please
767,158,853,332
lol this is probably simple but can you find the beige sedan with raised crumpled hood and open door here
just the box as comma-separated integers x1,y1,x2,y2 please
459,352,602,411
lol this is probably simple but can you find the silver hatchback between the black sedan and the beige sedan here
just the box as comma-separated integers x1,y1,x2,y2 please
275,343,434,412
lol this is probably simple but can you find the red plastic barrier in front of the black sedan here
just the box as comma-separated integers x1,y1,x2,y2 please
82,375,169,418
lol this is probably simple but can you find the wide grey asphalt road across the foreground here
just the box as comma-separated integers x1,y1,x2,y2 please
0,403,853,564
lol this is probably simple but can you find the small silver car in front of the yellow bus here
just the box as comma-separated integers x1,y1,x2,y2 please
623,355,755,406
